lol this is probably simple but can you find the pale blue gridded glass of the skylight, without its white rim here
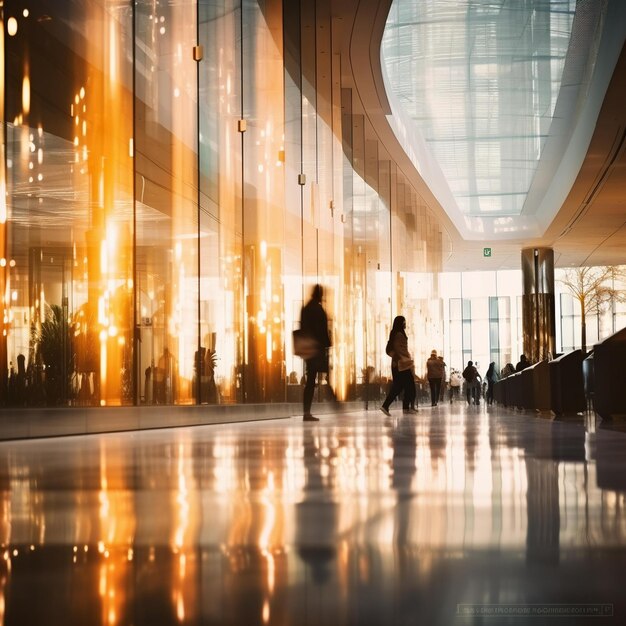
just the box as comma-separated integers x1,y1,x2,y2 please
381,0,584,218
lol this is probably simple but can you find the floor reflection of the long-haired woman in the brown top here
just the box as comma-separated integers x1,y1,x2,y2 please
391,418,417,547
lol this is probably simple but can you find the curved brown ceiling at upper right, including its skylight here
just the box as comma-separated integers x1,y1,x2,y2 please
342,0,626,271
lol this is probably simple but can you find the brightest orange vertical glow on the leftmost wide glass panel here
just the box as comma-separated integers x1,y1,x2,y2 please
73,9,133,406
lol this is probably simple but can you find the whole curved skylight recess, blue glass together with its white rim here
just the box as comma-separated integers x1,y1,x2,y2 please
381,0,623,239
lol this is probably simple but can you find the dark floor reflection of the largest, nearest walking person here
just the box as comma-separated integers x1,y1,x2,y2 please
295,431,338,585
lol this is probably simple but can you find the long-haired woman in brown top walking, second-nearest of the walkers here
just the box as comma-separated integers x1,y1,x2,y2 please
380,315,417,416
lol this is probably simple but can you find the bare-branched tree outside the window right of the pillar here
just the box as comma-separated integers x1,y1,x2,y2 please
559,265,624,352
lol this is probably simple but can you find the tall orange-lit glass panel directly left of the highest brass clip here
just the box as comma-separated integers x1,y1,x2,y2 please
135,0,199,404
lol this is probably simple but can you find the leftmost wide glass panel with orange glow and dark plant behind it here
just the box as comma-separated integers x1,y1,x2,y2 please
0,3,133,406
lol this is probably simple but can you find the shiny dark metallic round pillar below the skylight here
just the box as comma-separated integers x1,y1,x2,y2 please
522,248,556,363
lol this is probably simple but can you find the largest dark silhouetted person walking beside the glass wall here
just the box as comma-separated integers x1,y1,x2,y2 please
300,285,337,422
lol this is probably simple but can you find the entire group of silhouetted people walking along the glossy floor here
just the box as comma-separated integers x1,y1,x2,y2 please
294,285,516,421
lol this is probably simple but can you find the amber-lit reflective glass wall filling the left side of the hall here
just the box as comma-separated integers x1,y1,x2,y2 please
0,0,442,406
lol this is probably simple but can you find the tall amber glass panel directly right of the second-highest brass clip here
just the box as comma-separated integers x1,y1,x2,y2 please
242,0,286,402
